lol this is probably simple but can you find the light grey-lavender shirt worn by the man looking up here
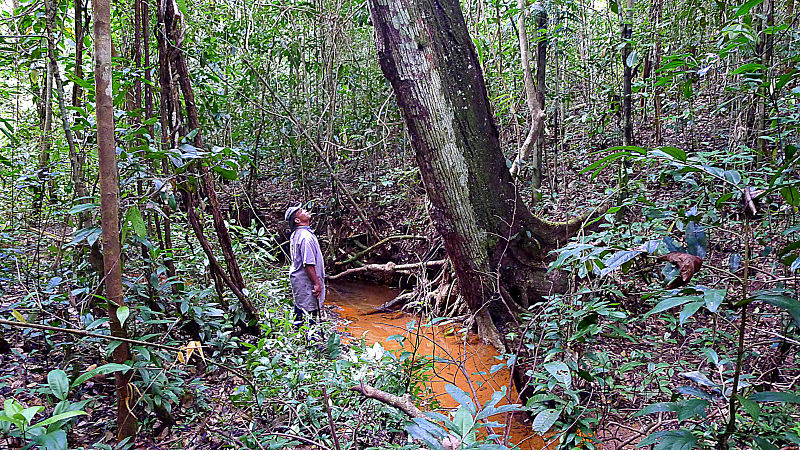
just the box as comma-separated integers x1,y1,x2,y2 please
289,226,325,311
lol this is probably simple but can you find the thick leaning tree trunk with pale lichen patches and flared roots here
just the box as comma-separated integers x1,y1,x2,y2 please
369,0,581,348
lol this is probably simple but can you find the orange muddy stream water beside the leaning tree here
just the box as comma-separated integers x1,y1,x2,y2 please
327,282,544,450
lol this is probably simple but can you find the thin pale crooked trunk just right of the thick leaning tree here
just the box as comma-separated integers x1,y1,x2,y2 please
511,0,545,181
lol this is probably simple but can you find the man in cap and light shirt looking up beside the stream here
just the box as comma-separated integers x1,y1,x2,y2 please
286,205,325,328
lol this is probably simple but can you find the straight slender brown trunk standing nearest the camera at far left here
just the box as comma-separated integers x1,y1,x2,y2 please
94,0,136,441
